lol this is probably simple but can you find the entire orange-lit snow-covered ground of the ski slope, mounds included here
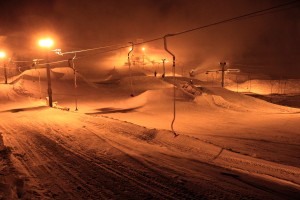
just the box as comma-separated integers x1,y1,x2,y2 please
0,68,300,199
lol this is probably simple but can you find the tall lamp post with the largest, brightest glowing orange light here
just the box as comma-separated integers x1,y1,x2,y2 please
39,38,54,107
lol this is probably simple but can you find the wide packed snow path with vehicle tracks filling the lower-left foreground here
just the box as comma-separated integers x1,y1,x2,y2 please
0,107,299,199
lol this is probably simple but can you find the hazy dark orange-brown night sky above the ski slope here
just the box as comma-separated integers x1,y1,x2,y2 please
0,0,300,78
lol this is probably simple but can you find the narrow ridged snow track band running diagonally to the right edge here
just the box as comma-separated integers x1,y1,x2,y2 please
85,115,300,193
